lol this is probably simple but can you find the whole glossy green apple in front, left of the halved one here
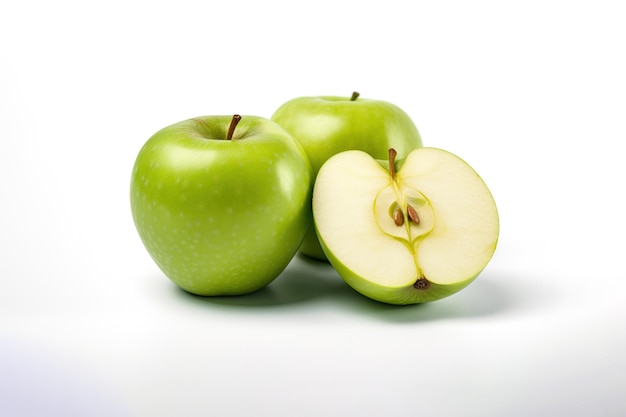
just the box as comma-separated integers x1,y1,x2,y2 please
130,116,313,295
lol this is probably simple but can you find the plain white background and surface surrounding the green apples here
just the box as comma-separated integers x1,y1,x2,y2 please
0,0,626,417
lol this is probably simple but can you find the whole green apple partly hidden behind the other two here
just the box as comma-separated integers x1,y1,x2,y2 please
272,92,422,260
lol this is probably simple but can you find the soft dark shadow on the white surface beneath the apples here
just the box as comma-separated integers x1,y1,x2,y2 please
168,256,546,323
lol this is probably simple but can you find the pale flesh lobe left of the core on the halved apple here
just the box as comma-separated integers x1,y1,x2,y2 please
313,151,417,287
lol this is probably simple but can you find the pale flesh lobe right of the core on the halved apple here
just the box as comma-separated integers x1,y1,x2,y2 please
397,148,499,284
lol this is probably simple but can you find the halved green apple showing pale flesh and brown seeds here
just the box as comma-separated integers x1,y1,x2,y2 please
313,148,499,304
